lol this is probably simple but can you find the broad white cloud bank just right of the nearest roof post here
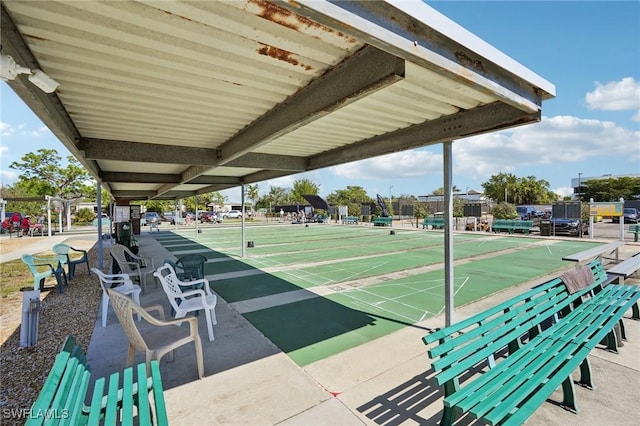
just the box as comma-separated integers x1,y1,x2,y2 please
453,116,640,179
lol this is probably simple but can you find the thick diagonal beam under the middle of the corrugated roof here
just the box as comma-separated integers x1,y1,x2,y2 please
165,46,405,197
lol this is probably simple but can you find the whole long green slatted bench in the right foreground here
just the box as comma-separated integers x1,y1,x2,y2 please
423,260,640,425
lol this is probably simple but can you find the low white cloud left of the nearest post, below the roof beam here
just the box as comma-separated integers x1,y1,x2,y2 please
330,150,442,180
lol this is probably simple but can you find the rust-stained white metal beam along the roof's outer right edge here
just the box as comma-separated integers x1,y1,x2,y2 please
276,0,555,113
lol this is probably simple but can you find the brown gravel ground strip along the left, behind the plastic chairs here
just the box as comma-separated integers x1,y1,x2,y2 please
0,247,108,425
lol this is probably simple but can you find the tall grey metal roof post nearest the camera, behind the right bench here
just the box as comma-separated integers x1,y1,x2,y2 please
442,141,455,327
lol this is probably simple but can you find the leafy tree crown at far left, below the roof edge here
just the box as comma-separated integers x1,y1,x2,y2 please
9,148,95,199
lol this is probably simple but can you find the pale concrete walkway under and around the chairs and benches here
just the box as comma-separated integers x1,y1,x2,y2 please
80,233,640,426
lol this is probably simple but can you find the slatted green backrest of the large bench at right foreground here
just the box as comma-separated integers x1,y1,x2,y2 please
423,261,606,386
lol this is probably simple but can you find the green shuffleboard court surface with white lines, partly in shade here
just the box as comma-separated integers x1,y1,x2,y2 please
154,225,595,365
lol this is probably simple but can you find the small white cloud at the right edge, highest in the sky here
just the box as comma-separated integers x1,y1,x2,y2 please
586,77,640,121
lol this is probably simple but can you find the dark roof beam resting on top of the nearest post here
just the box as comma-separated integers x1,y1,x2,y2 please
309,102,541,170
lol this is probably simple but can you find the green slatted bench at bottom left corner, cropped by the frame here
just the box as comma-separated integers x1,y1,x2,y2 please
25,336,169,426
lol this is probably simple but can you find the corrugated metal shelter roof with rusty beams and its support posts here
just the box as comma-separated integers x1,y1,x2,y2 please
0,0,555,325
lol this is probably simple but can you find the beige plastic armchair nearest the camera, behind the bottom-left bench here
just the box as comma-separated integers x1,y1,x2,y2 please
107,289,204,379
